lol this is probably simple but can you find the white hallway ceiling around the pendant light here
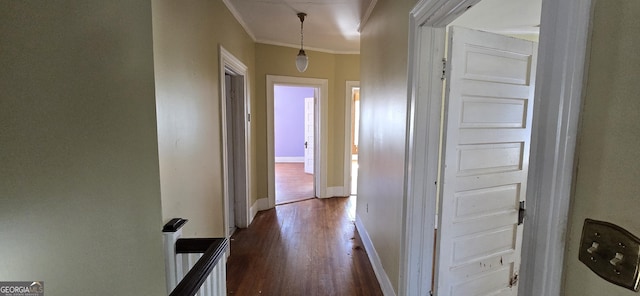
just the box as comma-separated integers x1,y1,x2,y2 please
223,0,374,53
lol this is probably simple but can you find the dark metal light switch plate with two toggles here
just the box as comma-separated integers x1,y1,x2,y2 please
579,219,640,292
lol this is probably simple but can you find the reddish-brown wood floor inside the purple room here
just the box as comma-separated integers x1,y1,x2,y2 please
275,163,315,205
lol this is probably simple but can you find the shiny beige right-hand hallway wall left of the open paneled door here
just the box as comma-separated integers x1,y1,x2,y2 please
357,0,416,291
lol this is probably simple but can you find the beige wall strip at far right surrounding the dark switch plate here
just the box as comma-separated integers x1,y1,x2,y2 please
563,0,640,296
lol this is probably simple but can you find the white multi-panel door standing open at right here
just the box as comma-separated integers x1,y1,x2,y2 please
436,27,537,296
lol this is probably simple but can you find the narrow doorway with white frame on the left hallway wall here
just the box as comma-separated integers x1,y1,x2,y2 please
220,47,251,238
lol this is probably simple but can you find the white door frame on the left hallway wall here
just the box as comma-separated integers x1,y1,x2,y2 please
219,46,251,238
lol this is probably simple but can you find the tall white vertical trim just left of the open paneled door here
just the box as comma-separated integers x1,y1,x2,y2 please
398,9,445,295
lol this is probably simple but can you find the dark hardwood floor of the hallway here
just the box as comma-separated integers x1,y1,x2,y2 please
227,197,382,296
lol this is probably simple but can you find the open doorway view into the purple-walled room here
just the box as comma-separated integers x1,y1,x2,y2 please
273,84,315,205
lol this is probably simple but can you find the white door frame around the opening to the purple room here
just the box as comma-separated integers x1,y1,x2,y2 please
267,75,329,208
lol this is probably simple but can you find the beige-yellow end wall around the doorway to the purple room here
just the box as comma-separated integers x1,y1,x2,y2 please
252,43,360,198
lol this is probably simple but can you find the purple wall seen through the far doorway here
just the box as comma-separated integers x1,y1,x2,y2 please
273,85,313,157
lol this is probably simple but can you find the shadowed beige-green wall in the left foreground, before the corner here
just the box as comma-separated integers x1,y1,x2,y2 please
0,0,166,295
